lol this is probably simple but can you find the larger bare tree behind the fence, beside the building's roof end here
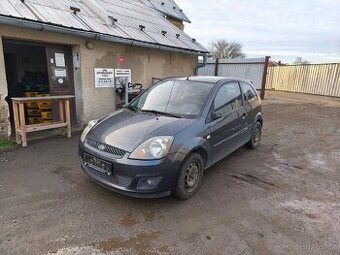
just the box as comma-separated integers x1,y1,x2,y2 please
209,39,245,59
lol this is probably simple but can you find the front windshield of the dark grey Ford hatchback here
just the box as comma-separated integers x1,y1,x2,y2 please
130,80,213,117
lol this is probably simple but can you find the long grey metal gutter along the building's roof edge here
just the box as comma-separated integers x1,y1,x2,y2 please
0,14,207,55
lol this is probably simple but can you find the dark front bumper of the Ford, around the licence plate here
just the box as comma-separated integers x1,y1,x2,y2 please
79,143,185,198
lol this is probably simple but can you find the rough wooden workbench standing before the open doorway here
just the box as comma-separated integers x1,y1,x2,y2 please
12,96,74,147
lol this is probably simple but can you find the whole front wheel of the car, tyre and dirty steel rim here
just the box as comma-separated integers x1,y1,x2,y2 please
174,153,204,200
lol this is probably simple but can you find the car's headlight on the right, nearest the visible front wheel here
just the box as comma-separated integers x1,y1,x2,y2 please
129,136,174,160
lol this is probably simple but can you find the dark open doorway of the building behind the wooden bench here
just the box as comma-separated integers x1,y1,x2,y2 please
3,39,76,133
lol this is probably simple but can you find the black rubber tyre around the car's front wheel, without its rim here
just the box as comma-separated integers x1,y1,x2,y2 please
174,153,204,200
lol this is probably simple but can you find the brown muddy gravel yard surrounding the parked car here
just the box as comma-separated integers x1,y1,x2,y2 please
0,92,340,255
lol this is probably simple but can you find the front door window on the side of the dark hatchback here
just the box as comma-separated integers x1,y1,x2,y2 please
213,82,242,115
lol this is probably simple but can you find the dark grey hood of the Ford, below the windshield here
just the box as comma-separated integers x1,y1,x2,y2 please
87,109,195,152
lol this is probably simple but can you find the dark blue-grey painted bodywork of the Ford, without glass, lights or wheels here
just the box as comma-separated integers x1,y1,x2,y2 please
79,77,263,197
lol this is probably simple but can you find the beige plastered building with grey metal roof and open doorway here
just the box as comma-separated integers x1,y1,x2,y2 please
0,0,207,137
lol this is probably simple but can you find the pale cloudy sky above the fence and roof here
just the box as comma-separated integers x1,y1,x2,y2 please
175,0,340,63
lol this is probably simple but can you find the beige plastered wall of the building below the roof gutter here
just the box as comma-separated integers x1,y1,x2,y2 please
0,25,197,138
